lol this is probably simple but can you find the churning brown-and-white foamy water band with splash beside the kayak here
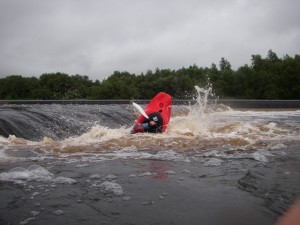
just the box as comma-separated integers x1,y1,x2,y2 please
0,87,300,165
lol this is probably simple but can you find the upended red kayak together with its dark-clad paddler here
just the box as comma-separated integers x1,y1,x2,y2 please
131,92,172,133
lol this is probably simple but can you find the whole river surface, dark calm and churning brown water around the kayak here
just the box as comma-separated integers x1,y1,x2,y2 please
0,92,300,224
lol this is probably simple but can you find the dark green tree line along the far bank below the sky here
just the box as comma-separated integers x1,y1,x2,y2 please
0,50,300,100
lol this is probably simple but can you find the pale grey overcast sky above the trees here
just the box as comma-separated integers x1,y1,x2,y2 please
0,0,300,80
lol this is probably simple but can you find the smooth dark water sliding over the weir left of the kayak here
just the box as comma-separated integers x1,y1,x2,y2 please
0,104,134,141
